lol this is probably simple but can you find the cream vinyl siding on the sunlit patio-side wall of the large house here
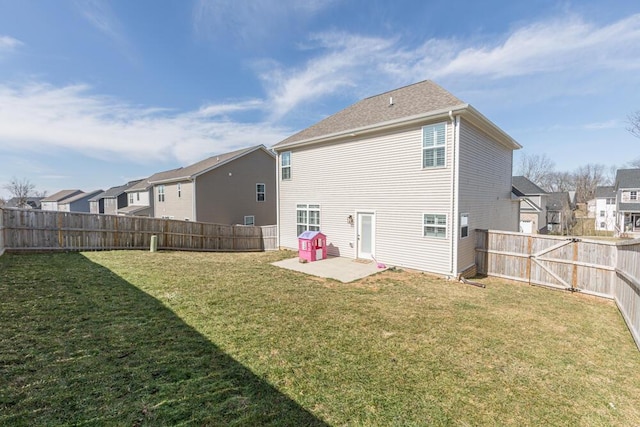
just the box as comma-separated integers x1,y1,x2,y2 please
279,125,452,274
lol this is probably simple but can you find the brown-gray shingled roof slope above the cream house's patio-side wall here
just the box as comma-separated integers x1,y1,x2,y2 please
274,80,466,148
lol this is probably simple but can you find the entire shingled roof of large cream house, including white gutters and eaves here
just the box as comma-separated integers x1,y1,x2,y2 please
273,80,522,149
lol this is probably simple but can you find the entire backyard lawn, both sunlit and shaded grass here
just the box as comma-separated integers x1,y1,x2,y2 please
0,251,640,426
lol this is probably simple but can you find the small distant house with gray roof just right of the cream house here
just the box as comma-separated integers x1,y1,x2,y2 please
511,176,549,233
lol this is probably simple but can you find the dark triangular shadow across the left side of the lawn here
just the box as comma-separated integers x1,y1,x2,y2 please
0,253,326,426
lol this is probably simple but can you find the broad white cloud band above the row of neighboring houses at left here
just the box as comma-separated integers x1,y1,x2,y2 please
0,83,290,164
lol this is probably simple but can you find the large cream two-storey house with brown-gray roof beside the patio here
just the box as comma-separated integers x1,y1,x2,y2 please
273,81,521,276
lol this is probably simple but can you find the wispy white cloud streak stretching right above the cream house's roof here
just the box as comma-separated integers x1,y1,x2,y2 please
257,14,640,118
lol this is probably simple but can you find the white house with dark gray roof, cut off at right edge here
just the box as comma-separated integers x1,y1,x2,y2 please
615,169,640,237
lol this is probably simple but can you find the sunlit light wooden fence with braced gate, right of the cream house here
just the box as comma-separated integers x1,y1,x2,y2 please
476,230,640,348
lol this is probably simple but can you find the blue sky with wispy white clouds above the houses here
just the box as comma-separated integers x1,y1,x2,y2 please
0,0,640,197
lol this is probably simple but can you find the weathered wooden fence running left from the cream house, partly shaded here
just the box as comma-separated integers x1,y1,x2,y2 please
0,209,277,254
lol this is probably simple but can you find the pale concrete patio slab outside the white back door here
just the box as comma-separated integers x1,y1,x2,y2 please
272,257,388,283
